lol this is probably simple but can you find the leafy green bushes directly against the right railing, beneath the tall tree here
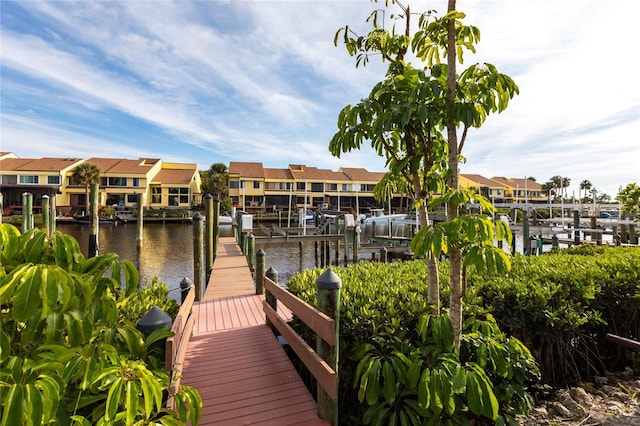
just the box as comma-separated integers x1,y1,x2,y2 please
287,261,539,424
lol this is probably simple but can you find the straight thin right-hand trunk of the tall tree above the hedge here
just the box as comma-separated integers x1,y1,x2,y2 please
447,0,463,348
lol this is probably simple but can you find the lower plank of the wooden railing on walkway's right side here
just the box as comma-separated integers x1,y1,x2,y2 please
262,301,338,399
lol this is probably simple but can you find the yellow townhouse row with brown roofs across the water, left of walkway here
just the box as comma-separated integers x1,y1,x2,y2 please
0,152,202,215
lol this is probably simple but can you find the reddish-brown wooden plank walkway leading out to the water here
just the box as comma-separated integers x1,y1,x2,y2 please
182,238,329,426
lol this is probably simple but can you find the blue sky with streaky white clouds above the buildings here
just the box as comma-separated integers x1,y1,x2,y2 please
0,0,640,197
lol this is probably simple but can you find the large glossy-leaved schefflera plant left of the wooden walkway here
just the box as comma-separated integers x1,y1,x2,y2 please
0,224,202,425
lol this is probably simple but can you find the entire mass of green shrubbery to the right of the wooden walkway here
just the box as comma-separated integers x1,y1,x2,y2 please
288,246,640,425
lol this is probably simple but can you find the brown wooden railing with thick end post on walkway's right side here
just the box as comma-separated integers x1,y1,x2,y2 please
263,269,342,426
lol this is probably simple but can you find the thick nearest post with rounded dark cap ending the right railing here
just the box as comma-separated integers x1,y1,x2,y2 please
316,269,342,426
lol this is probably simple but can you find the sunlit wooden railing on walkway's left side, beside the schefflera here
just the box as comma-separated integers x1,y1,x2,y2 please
165,285,196,409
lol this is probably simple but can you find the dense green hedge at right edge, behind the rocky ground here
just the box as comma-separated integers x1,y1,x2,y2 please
467,246,640,385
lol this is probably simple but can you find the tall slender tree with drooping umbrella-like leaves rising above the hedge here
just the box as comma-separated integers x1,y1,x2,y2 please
329,1,518,341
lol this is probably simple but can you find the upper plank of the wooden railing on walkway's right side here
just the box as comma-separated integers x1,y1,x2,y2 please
264,277,336,345
